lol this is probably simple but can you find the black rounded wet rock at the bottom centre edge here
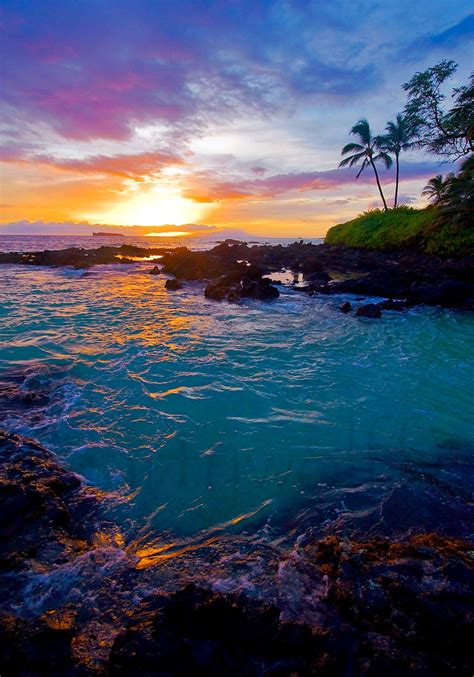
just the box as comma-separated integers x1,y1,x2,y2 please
109,585,325,677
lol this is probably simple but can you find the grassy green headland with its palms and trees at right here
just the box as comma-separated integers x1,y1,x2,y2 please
336,60,474,264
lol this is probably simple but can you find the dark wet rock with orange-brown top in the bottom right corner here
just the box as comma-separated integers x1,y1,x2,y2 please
300,533,474,675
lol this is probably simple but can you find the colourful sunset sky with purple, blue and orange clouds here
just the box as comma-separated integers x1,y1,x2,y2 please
0,0,474,237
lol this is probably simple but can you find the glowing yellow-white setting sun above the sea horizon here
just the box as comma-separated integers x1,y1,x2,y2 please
85,186,212,226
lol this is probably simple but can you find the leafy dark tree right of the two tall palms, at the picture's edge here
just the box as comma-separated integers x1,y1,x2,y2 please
403,59,474,160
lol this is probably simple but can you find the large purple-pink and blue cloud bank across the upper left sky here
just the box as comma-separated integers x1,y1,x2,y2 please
0,0,378,147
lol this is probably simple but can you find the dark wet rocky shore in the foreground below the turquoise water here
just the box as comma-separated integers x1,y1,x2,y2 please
0,422,474,675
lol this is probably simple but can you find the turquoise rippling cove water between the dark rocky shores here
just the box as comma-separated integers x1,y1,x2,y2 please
0,256,474,541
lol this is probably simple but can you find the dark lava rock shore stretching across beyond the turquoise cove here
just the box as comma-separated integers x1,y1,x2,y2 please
0,240,474,310
